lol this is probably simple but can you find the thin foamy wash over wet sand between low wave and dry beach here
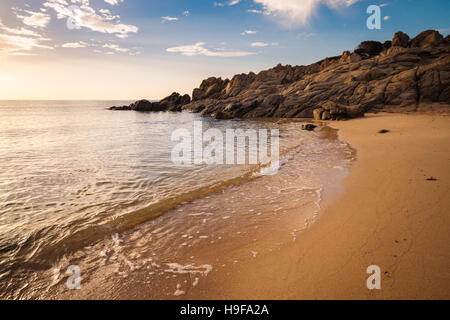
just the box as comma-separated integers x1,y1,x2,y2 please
34,120,355,299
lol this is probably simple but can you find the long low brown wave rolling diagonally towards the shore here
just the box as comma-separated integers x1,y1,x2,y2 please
0,145,301,275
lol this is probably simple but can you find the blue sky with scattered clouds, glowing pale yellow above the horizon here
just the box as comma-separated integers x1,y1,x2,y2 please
0,0,450,100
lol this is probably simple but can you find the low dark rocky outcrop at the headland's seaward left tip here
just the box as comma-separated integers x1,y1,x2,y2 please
109,92,191,112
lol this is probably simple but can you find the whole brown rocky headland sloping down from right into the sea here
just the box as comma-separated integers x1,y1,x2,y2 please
111,30,450,120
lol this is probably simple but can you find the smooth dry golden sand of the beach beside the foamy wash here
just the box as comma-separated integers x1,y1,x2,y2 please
192,114,450,299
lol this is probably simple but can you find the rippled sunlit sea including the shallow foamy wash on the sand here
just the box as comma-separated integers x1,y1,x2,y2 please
0,101,353,298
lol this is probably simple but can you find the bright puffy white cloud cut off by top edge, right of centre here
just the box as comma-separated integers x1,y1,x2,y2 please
253,0,359,27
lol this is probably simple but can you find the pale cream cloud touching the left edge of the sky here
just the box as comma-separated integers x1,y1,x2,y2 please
0,20,53,55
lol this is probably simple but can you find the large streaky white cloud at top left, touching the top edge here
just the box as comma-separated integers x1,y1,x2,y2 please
44,0,139,38
